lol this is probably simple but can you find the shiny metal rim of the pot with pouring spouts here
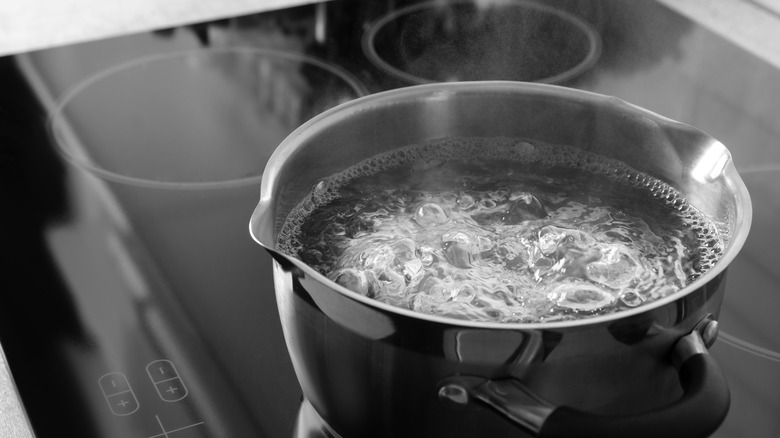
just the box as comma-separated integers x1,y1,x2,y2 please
249,81,753,330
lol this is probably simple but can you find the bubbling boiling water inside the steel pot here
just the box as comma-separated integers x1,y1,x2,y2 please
278,138,722,322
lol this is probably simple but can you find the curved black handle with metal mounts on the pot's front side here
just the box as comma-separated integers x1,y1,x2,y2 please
439,321,730,438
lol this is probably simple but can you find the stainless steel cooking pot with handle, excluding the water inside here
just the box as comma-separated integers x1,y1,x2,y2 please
250,81,751,437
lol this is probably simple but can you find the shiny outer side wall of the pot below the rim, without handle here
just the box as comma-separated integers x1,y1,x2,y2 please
274,263,725,438
